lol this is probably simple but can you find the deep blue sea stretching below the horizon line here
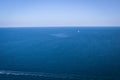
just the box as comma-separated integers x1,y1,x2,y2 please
0,27,120,80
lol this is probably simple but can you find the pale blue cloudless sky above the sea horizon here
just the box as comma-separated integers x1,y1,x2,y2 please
0,0,120,27
